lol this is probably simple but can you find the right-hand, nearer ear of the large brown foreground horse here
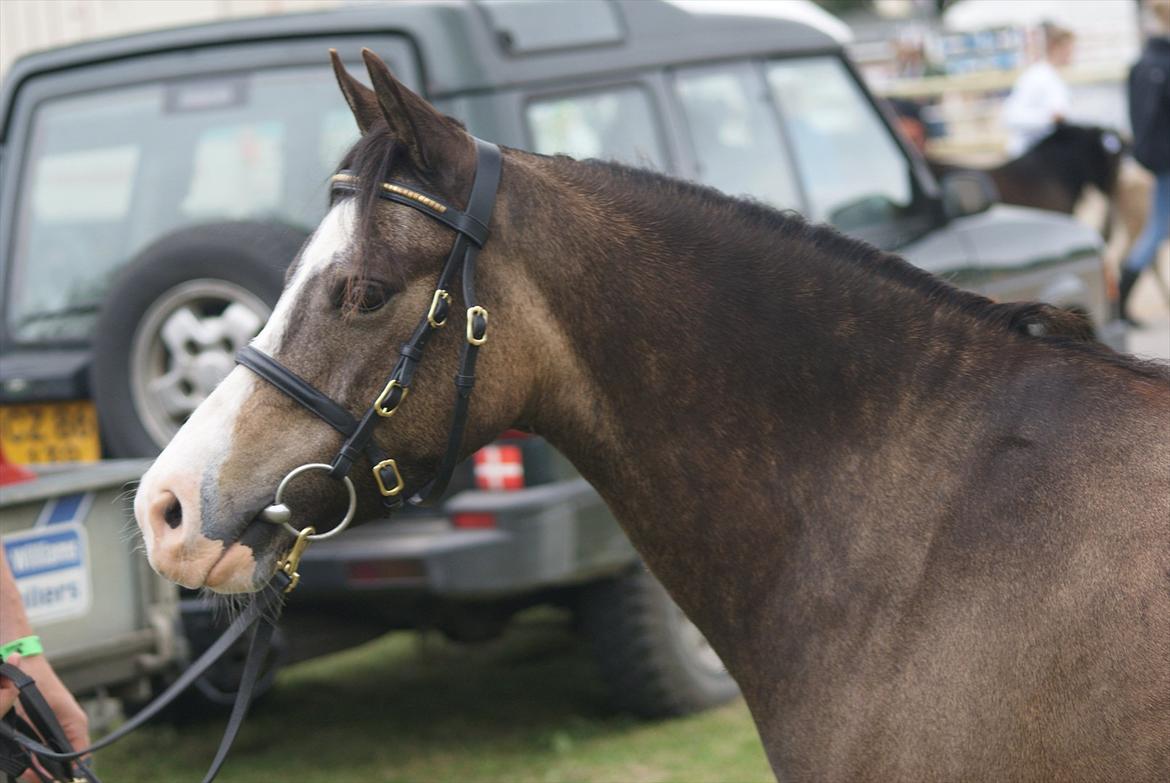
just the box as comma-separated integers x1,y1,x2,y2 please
362,49,467,171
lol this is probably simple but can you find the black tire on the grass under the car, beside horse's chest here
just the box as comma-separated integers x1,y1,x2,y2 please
577,565,739,717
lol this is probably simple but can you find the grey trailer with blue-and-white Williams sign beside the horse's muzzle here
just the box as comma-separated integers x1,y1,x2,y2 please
0,460,180,727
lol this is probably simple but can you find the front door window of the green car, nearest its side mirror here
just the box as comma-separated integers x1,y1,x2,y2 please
766,57,915,231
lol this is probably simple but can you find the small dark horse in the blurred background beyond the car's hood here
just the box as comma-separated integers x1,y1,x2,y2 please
928,123,1124,225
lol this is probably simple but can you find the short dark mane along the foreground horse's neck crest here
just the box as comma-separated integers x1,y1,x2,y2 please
561,156,1170,380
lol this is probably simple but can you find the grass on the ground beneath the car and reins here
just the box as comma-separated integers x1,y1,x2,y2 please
96,611,775,783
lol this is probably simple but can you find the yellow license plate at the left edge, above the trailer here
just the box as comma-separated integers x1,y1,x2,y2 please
0,400,102,465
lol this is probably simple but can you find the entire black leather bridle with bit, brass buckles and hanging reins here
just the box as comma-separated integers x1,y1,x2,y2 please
0,138,502,783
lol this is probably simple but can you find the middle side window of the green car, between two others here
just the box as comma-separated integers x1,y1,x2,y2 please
675,62,800,208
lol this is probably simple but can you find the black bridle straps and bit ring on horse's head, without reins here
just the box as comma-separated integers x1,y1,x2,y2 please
235,139,501,522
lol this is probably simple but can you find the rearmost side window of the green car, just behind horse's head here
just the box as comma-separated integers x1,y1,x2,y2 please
525,85,666,171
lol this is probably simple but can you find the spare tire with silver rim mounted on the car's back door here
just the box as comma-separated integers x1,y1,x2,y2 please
90,222,305,458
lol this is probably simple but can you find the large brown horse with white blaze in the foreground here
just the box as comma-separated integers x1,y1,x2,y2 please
135,50,1170,781
